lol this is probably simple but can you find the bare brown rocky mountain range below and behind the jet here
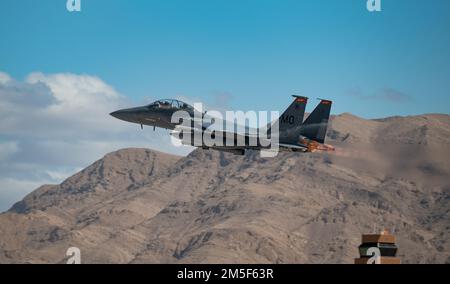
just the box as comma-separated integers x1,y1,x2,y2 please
0,114,450,263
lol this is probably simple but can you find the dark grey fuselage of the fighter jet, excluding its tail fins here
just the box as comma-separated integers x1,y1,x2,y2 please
111,99,333,154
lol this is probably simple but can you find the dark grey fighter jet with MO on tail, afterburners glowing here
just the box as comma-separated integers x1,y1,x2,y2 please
110,96,334,155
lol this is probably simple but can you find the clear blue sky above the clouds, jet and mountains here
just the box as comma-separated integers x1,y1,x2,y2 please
0,0,450,118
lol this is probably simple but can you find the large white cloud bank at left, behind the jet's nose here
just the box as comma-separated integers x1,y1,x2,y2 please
0,72,191,211
